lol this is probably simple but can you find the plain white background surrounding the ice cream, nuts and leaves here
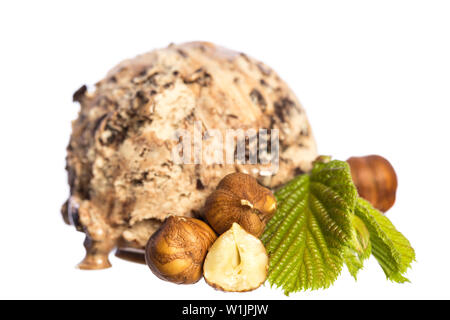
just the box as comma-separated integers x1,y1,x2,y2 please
0,0,450,299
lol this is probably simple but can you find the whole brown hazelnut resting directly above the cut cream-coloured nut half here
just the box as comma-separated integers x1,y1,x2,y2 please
205,172,277,237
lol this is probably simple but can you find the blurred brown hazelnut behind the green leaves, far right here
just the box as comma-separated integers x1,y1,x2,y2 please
347,155,398,212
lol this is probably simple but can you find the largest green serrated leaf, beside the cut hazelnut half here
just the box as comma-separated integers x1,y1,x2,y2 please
261,160,357,295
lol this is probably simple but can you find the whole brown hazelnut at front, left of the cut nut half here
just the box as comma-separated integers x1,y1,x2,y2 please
145,216,217,284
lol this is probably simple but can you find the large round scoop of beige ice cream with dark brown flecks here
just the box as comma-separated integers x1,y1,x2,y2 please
62,42,317,269
